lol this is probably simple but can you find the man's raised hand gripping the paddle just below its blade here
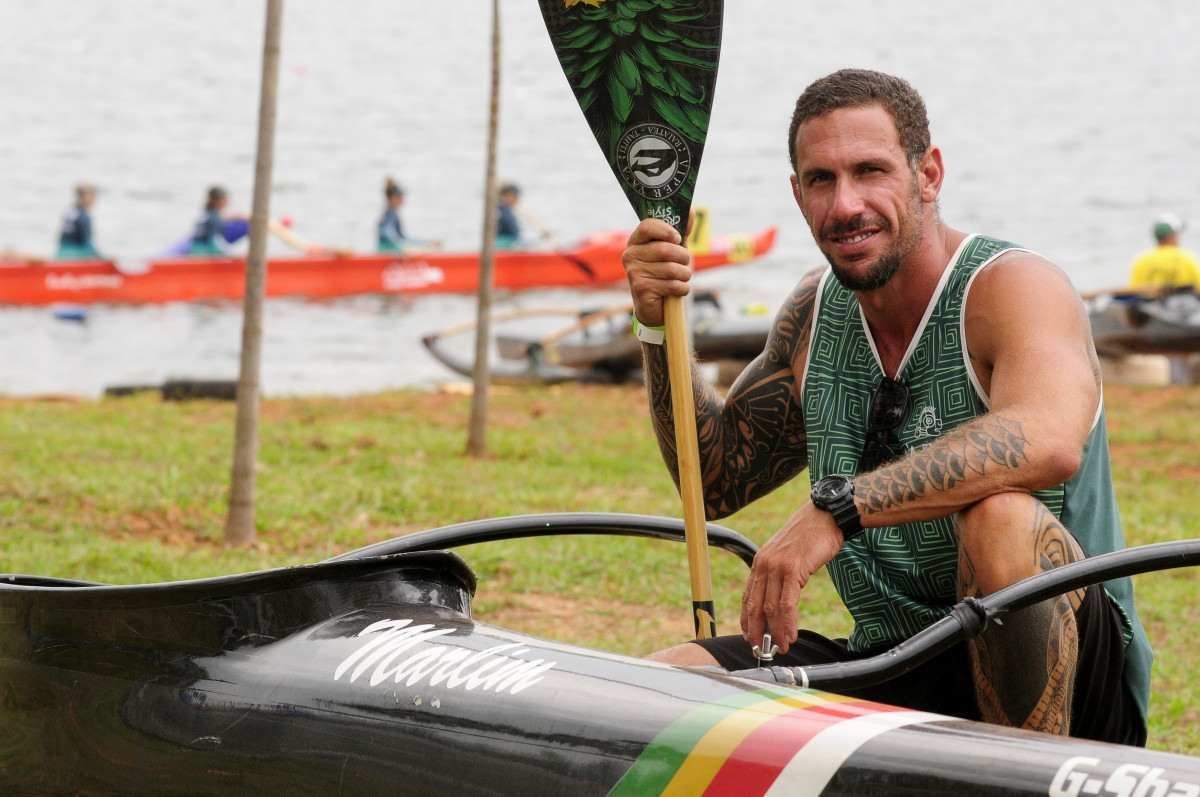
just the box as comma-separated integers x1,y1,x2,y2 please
620,218,691,326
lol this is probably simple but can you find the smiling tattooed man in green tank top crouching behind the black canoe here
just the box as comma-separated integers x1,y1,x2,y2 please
624,70,1151,744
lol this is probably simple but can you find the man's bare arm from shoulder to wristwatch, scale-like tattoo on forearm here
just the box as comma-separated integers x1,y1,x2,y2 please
854,253,1100,526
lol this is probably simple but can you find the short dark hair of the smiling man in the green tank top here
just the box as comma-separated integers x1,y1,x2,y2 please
787,70,929,172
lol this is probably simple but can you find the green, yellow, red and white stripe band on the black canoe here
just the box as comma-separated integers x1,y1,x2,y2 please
611,688,900,796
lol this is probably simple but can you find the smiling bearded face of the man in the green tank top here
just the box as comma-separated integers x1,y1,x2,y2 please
792,104,936,290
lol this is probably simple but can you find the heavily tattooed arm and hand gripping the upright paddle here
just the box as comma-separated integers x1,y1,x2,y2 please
624,220,820,519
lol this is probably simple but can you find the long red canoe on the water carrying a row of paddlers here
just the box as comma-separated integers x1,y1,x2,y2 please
0,227,775,305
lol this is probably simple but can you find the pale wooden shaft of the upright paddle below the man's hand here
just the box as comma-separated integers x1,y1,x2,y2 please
664,296,716,640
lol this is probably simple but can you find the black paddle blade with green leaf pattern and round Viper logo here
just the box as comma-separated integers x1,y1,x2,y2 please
539,0,724,234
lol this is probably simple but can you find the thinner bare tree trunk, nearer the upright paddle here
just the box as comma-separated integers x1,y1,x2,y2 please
467,0,500,456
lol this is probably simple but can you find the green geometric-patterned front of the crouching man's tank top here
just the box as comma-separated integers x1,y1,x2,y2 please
804,235,1064,652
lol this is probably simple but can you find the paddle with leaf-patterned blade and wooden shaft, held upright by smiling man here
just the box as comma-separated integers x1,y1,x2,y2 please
539,0,724,639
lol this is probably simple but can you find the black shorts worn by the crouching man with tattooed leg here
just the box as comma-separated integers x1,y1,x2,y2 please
695,586,1146,747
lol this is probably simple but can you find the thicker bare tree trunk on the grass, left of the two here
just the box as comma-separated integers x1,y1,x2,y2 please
224,0,283,545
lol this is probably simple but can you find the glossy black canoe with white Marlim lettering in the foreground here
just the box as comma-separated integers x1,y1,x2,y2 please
0,515,1200,797
